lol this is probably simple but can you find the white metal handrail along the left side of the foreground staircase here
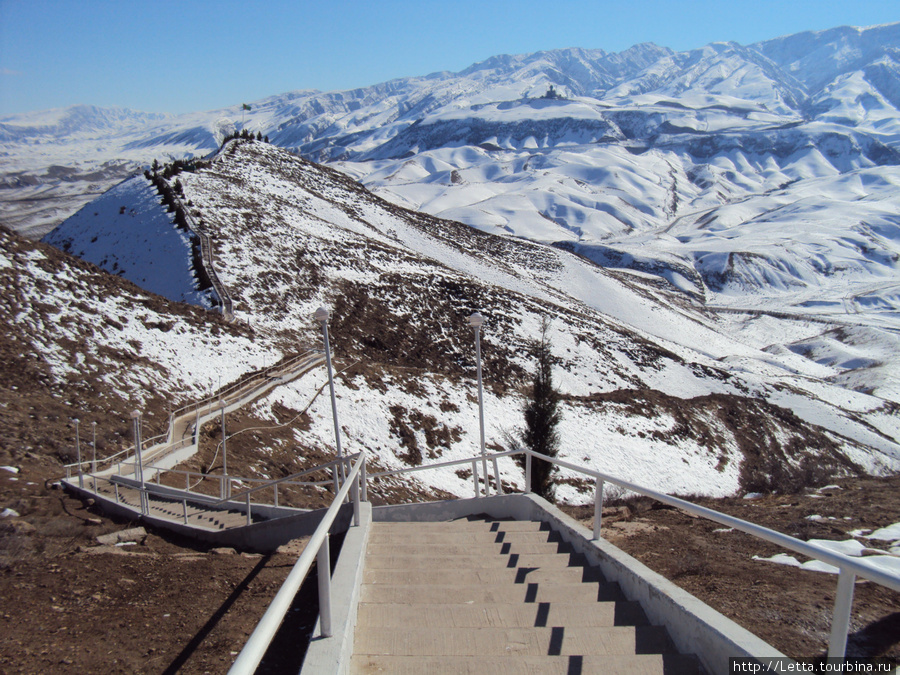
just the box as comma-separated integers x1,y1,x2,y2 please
228,451,366,675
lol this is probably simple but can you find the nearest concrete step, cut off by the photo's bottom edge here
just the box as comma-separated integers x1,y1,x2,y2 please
350,654,700,675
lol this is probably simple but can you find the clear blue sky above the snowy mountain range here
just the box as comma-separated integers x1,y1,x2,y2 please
0,0,900,115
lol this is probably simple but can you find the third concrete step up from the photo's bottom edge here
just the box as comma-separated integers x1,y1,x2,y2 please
358,601,648,628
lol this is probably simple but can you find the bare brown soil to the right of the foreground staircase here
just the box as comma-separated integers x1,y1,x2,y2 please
565,476,900,664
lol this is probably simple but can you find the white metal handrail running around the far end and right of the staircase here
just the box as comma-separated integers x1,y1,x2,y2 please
369,448,900,657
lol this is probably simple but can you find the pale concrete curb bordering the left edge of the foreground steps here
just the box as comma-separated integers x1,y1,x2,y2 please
300,502,372,675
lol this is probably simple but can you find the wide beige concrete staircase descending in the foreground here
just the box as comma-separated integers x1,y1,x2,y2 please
350,518,699,675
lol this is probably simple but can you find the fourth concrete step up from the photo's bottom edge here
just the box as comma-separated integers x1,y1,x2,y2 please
360,582,626,605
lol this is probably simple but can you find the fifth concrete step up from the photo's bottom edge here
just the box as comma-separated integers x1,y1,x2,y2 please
363,566,595,587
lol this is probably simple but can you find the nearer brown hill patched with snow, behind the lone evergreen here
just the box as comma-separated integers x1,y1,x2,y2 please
31,141,900,501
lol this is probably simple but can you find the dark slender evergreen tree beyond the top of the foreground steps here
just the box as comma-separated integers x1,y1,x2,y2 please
522,315,561,501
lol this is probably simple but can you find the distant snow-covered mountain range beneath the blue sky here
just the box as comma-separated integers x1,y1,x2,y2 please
0,24,900,322
